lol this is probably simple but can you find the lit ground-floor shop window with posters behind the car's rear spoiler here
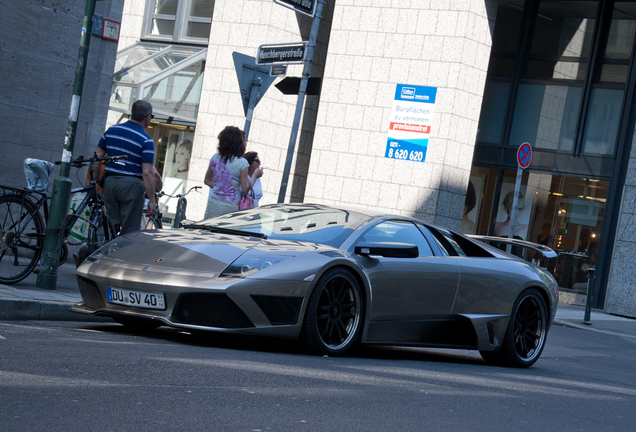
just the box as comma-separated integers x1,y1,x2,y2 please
461,167,609,291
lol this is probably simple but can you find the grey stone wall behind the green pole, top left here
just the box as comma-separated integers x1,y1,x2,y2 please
0,0,124,187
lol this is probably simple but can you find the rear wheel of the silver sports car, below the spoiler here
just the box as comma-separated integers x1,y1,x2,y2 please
480,288,548,368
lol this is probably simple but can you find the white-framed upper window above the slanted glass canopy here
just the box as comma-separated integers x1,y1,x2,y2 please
142,0,214,45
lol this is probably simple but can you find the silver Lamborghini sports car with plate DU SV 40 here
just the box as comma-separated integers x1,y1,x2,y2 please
73,204,558,367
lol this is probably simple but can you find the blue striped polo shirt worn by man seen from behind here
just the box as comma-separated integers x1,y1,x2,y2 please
98,121,155,177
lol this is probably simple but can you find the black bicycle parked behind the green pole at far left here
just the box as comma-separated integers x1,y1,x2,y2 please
0,156,126,284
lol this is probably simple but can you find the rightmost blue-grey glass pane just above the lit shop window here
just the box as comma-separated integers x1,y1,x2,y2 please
583,88,623,155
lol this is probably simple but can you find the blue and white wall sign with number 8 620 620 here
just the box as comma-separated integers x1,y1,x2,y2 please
384,84,437,162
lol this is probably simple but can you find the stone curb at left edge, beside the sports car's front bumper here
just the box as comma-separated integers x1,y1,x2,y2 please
0,299,112,322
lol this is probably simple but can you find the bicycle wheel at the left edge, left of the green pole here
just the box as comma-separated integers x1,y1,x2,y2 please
0,195,44,284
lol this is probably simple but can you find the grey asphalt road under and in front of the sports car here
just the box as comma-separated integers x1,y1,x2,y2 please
0,321,636,432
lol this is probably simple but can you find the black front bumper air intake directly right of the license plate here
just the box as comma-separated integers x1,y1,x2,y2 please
172,293,254,328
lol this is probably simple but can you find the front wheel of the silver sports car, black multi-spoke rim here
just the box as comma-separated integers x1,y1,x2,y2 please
304,268,363,356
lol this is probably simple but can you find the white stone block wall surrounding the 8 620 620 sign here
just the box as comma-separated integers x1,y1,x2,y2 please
304,0,496,230
